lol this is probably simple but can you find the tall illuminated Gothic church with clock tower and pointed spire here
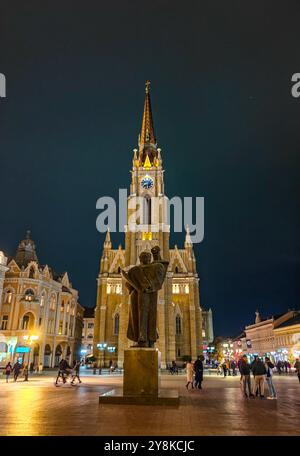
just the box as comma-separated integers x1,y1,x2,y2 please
94,82,205,367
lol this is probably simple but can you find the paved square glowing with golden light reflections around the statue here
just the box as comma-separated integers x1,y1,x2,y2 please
0,373,300,436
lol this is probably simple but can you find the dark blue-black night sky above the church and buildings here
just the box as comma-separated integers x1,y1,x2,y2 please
0,0,300,335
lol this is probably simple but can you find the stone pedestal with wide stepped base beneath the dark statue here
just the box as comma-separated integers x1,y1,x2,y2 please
99,347,179,406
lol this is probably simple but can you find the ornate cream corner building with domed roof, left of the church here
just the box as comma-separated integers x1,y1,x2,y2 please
0,232,83,367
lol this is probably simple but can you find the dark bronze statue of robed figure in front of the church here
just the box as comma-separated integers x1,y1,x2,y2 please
122,246,169,347
